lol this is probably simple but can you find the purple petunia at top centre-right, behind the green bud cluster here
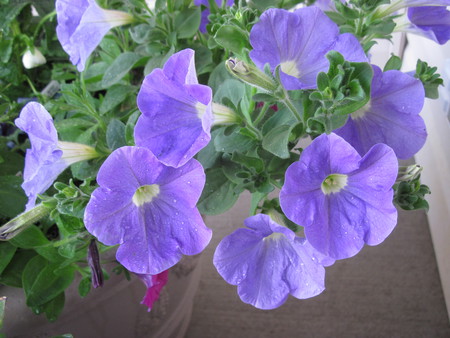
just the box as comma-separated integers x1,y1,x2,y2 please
250,6,367,90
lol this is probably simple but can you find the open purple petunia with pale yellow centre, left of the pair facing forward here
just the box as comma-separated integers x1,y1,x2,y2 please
84,147,211,275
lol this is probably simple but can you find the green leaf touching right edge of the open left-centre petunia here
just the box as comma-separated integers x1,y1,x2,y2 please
197,168,243,215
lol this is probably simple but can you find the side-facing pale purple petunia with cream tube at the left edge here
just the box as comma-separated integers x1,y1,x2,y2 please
14,102,98,210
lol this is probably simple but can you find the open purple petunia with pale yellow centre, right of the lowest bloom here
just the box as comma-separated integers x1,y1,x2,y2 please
280,133,398,259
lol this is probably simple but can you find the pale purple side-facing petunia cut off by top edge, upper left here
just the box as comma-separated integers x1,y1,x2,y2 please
55,0,133,72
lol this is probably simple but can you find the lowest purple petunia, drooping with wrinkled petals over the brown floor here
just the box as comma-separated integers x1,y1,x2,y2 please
213,214,334,310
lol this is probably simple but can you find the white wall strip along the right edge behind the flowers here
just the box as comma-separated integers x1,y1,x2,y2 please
403,35,450,318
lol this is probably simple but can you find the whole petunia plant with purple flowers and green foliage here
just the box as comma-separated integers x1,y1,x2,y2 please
0,0,444,320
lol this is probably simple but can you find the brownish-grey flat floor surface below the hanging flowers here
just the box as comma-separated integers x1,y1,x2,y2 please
186,196,450,338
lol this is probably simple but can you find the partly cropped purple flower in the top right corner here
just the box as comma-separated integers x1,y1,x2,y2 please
407,6,450,45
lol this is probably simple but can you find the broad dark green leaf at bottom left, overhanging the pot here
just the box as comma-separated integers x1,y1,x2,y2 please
22,256,75,307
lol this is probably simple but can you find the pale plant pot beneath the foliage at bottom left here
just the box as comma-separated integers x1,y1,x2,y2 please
0,255,201,338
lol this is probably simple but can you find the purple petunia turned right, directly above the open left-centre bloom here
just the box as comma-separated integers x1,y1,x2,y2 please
134,49,213,167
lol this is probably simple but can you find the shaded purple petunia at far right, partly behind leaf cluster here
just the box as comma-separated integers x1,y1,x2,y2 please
334,66,427,159
